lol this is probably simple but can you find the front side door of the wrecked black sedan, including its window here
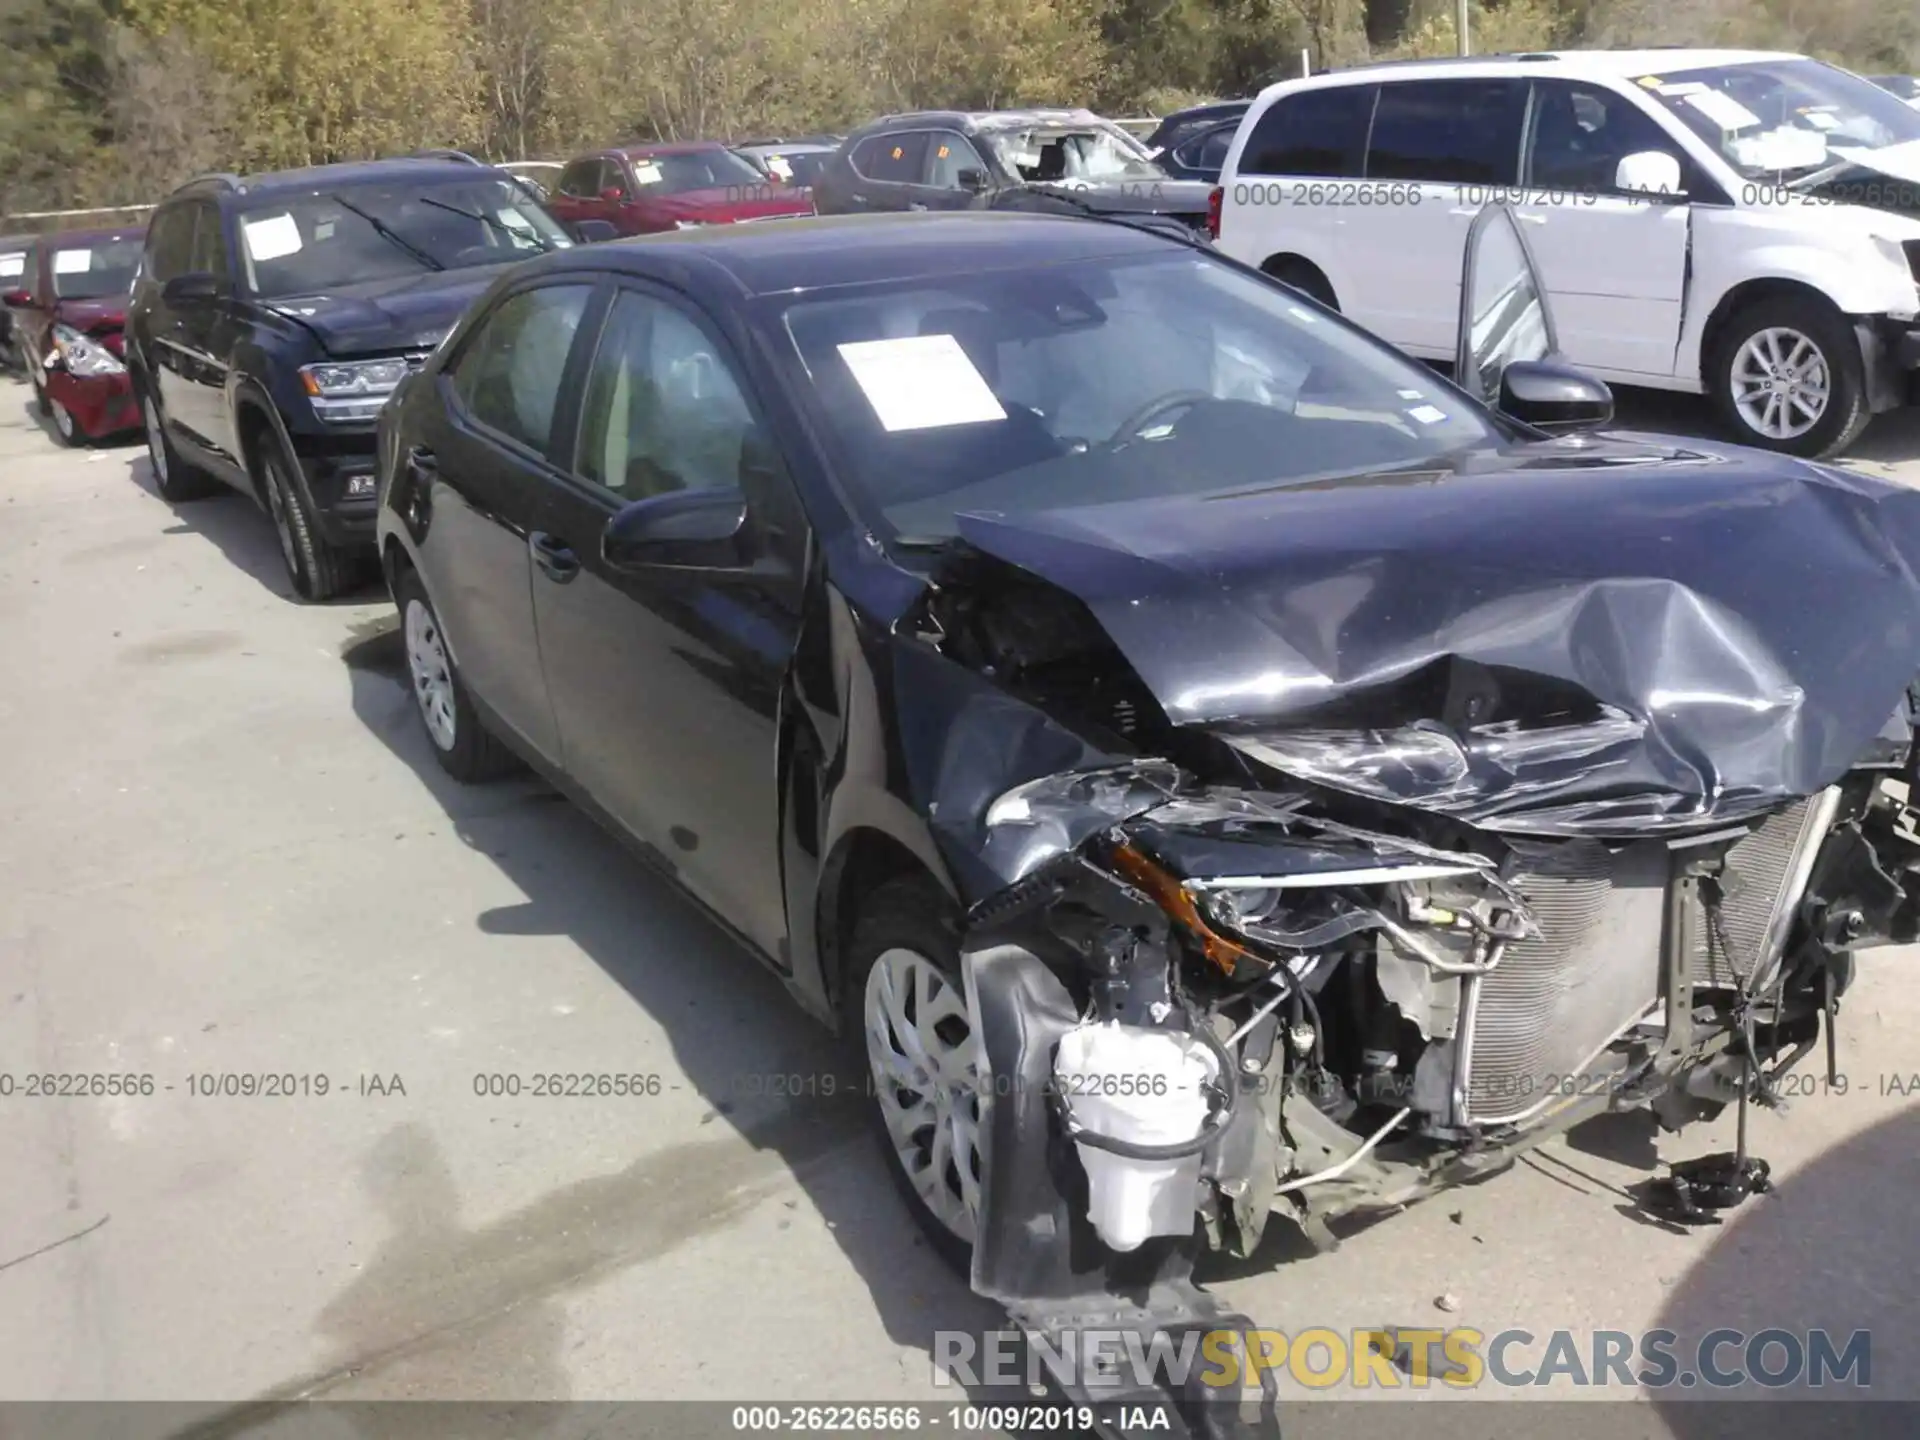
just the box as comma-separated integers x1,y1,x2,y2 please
534,288,804,958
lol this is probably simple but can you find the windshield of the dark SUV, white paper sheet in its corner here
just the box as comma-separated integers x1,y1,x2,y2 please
240,177,570,300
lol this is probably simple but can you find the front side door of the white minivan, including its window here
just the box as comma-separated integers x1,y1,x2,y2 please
1515,79,1711,376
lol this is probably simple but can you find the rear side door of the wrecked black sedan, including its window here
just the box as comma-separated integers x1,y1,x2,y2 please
416,276,593,764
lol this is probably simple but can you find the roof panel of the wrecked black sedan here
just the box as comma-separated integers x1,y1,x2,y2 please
528,211,1181,296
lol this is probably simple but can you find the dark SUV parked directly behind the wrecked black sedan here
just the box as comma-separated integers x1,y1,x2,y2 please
127,156,570,601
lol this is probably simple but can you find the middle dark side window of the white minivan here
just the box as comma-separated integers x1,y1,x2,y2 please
1367,77,1526,184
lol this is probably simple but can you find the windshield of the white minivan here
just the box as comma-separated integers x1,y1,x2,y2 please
1640,60,1920,180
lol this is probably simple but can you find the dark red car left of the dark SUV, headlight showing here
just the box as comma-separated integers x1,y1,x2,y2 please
4,228,146,445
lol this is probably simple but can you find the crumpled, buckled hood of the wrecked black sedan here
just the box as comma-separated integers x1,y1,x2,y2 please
960,436,1920,835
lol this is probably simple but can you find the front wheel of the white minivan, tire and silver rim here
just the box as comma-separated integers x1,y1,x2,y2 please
1707,296,1874,459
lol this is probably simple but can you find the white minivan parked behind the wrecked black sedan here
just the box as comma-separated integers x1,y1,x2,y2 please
1215,50,1920,455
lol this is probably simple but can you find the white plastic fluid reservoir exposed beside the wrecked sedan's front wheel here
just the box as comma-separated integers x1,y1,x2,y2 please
1054,1021,1219,1250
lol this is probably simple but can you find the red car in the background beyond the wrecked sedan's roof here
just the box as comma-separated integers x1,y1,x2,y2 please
547,140,814,234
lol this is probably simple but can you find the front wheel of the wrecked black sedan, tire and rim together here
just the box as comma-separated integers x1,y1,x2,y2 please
841,879,983,1275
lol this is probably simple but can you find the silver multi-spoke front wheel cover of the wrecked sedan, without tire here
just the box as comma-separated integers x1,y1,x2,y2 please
862,948,981,1244
